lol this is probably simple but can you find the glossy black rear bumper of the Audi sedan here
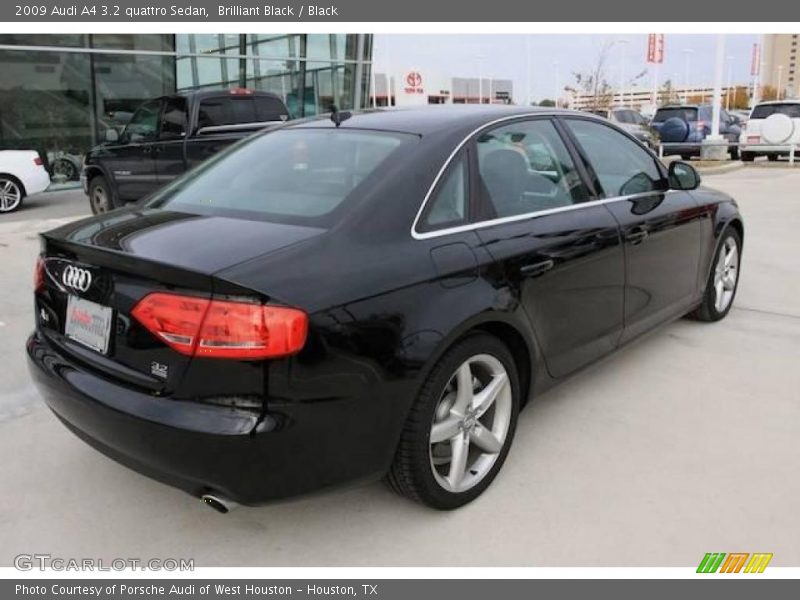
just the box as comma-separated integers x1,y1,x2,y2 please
27,332,395,505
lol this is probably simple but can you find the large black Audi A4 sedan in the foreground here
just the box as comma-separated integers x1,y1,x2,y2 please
27,106,744,511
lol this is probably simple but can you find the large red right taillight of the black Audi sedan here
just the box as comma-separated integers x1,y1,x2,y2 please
131,292,308,360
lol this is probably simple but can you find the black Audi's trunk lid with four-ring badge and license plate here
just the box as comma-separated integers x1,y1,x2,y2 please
36,209,324,394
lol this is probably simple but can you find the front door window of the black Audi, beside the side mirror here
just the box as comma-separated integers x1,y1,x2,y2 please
566,119,667,198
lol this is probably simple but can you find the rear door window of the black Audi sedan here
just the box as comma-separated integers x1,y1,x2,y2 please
476,119,589,218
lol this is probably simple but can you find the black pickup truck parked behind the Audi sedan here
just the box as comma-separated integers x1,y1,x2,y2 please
81,88,289,214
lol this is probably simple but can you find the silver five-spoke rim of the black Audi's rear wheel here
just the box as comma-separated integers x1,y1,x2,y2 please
429,354,512,493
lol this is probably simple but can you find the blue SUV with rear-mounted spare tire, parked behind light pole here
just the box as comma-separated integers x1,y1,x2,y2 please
651,104,741,160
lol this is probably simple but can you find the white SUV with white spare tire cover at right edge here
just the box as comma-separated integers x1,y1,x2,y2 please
740,100,800,162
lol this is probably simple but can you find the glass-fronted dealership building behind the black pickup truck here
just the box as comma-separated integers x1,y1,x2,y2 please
0,34,372,166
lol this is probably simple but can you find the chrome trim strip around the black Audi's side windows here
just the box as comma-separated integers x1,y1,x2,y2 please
411,112,675,240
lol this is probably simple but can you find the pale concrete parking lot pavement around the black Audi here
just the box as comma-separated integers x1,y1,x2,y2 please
0,168,800,566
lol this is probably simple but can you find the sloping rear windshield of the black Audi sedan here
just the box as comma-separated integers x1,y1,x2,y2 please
148,128,417,226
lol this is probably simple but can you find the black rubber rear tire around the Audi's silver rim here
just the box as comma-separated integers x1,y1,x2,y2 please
386,333,520,510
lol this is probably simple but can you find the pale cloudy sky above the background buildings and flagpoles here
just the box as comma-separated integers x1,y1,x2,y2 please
374,34,760,103
